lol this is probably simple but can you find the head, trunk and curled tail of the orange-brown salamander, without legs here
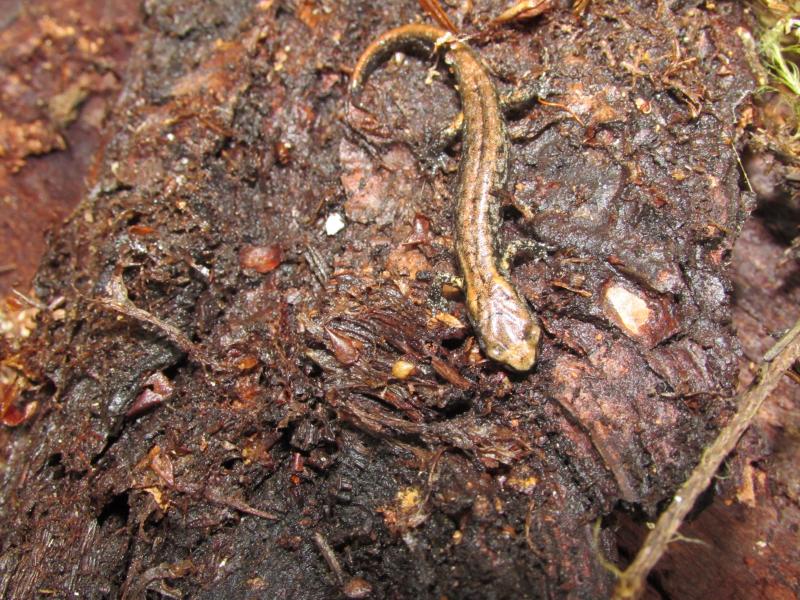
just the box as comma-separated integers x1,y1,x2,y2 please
350,24,541,371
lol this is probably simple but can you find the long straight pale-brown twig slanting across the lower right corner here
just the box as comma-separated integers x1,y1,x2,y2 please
613,320,800,600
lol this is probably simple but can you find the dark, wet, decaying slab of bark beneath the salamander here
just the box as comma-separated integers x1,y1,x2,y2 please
0,0,792,598
